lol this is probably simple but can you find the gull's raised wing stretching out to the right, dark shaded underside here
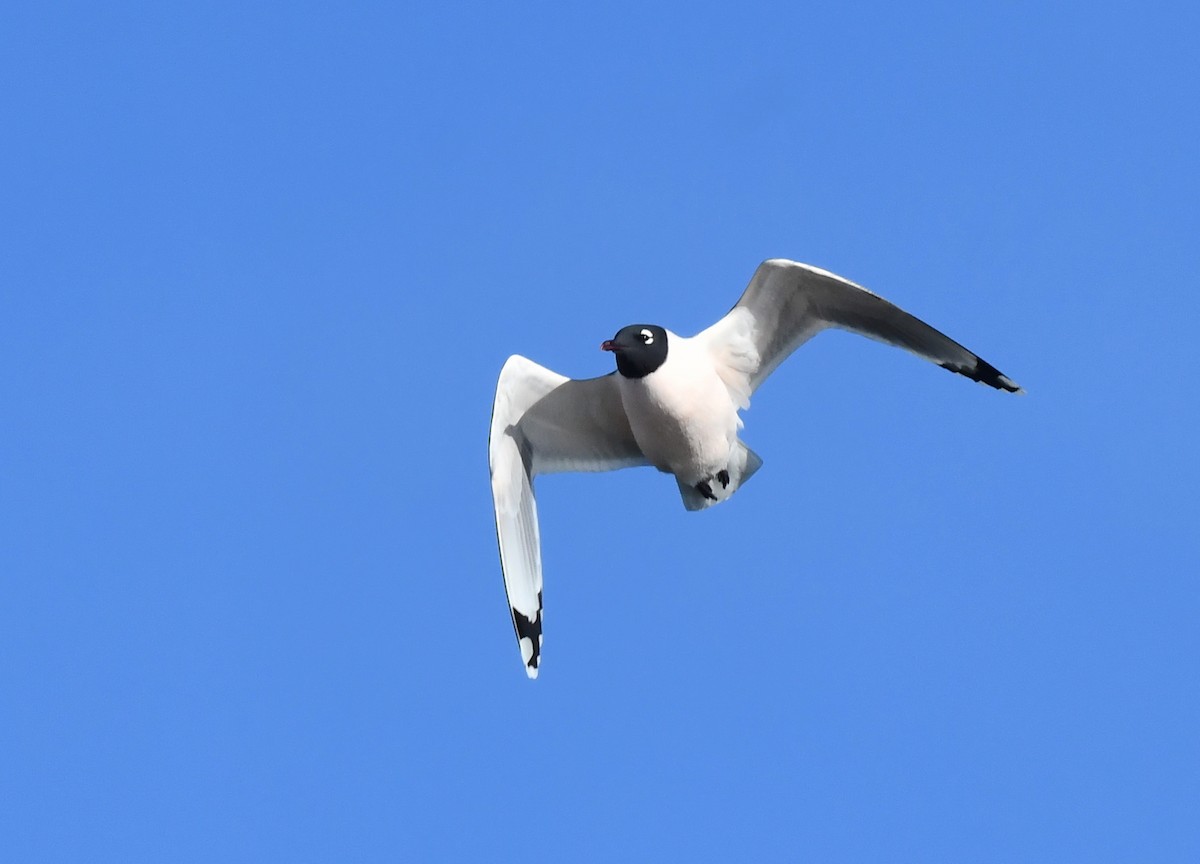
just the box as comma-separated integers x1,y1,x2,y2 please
701,258,1021,392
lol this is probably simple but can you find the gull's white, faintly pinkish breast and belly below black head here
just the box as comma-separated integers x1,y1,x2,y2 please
618,332,739,485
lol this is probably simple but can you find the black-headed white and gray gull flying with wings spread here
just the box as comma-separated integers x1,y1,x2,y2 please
488,258,1022,678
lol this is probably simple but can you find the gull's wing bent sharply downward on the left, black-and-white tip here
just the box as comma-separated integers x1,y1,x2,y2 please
487,355,647,678
